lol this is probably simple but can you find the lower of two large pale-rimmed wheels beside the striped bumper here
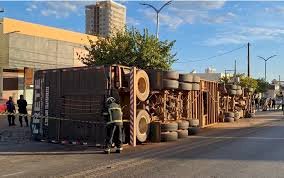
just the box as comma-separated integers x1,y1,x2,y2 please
136,109,150,143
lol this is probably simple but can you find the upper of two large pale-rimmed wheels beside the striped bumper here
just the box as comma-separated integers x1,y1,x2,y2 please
136,70,150,101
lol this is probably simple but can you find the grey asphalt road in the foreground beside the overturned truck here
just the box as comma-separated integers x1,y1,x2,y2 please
0,112,284,178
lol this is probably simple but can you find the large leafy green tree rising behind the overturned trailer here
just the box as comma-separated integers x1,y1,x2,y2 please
79,29,177,70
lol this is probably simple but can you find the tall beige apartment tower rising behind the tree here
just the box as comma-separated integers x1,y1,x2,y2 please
85,0,126,37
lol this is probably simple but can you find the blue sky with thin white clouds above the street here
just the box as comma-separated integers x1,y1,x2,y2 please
0,0,284,81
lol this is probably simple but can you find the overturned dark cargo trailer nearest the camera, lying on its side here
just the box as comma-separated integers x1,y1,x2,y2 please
32,65,220,146
